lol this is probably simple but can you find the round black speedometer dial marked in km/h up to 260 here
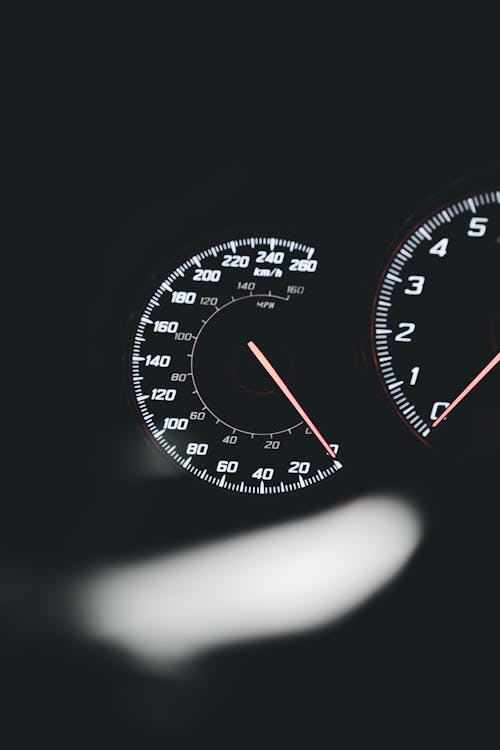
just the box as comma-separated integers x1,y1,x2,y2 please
131,237,342,494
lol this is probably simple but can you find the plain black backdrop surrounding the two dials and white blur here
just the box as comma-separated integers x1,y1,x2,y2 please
2,14,500,747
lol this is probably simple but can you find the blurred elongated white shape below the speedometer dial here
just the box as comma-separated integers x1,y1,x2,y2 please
77,496,423,666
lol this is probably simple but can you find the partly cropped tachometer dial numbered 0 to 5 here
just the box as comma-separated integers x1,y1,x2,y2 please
372,187,500,453
